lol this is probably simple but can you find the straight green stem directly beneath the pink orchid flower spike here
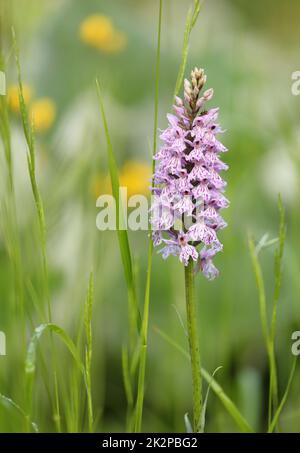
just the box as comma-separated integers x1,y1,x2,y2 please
184,260,202,433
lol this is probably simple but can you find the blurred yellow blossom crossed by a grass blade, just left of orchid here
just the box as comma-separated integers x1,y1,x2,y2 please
90,161,152,201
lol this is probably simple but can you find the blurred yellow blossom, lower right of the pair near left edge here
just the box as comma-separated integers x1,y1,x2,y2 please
29,98,56,132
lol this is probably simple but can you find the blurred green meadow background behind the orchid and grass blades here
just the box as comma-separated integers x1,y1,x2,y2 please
0,0,300,432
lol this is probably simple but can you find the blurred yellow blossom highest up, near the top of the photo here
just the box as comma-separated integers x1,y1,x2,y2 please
79,14,127,53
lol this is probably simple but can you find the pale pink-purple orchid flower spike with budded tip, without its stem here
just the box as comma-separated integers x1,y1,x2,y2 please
151,68,229,279
